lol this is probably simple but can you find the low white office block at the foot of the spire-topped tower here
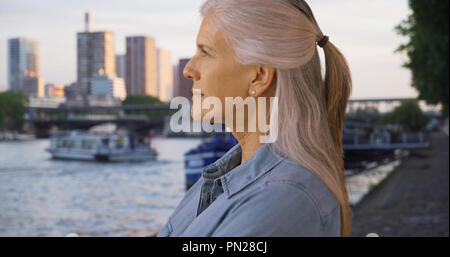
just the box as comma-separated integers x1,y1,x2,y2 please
91,73,127,101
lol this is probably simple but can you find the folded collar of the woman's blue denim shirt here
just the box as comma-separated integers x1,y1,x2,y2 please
202,144,286,198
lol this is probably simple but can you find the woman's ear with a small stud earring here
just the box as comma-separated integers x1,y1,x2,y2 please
248,65,275,97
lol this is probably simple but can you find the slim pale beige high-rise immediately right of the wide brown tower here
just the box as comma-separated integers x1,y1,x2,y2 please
157,48,173,102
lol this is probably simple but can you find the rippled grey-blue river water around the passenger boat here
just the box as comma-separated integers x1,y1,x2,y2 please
0,138,400,236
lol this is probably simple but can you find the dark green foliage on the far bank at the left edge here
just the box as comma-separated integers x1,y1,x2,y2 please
0,91,27,130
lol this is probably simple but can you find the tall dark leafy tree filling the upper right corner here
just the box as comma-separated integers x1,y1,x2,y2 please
395,0,449,116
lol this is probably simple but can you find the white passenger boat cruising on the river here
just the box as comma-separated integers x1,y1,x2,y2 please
46,123,157,162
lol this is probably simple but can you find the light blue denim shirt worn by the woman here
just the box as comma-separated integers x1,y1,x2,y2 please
156,144,340,237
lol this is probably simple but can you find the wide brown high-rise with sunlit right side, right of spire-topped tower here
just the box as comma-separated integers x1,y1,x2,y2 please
125,36,158,97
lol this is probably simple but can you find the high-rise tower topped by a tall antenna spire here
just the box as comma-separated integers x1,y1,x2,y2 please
77,13,116,96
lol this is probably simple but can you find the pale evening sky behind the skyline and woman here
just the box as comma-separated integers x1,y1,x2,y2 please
0,0,417,99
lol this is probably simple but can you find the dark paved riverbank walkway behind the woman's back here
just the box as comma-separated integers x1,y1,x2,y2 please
352,132,449,237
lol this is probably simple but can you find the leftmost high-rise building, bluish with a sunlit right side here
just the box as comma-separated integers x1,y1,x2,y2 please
8,37,42,94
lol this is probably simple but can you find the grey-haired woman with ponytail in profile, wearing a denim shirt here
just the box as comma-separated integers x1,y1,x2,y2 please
157,0,351,236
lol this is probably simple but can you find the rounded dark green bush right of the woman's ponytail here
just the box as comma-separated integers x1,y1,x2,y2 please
380,100,430,131
